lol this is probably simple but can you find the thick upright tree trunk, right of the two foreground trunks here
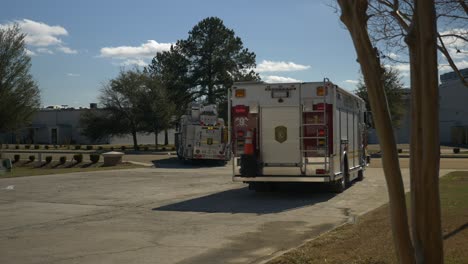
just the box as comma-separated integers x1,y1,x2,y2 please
406,0,444,263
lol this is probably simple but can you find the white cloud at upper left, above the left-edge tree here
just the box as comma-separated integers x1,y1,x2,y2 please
0,19,77,54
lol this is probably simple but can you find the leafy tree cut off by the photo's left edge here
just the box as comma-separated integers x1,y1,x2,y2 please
0,25,41,132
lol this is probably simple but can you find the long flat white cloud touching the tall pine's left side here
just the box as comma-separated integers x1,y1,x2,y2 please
100,40,172,59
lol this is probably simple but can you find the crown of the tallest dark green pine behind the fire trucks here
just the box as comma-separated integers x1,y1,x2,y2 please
147,17,260,121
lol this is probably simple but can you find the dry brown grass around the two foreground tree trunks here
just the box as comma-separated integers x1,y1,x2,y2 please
269,172,468,264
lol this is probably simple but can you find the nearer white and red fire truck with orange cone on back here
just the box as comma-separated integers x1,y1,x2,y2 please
228,78,367,192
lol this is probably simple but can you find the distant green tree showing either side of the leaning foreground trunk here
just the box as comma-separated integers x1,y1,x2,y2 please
355,67,405,128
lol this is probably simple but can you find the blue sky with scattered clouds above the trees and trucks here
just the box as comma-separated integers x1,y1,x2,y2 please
0,0,464,107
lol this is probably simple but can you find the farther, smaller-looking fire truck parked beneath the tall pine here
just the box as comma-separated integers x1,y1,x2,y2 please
175,104,231,163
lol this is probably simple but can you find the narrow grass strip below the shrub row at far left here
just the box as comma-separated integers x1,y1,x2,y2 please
0,162,143,179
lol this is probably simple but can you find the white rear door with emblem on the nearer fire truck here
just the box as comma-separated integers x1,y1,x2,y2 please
260,106,301,166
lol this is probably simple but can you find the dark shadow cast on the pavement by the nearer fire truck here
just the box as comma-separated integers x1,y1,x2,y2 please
153,185,336,214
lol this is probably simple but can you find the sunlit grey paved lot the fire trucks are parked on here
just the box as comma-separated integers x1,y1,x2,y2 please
0,159,460,263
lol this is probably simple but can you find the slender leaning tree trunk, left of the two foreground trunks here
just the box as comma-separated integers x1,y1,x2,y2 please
338,0,415,264
